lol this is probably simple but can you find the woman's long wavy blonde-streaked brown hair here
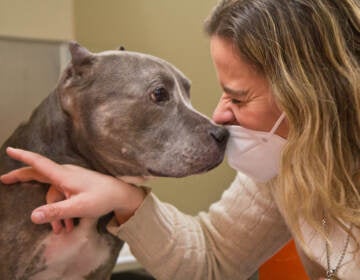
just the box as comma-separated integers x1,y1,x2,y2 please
205,0,360,248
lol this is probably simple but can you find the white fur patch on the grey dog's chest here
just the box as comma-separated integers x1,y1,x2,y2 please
23,219,111,280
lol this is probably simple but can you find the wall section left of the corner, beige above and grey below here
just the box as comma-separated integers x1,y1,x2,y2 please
0,0,74,143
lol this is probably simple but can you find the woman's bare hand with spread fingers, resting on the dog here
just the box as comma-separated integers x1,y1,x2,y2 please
0,148,145,232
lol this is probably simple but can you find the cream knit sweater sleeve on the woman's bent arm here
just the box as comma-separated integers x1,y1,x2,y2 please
108,174,290,280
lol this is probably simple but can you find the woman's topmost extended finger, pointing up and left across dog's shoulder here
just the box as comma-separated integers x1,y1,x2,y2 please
6,147,63,183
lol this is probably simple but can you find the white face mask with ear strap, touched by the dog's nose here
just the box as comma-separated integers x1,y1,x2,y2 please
226,113,286,183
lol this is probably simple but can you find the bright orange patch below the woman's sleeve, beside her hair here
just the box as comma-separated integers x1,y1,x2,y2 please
259,241,309,280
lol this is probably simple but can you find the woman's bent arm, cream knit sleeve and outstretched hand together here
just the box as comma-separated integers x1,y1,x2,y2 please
1,149,290,280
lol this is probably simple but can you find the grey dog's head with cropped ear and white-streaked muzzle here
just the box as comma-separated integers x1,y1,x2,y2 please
57,43,228,177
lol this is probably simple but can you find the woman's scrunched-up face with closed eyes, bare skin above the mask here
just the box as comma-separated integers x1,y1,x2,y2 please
210,36,288,138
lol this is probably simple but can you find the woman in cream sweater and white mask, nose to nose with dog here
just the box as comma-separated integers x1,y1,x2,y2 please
1,0,360,280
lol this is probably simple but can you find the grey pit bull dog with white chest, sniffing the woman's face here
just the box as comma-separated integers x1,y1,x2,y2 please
0,42,228,280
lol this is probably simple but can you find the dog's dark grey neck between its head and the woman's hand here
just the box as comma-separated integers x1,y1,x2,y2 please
0,90,90,171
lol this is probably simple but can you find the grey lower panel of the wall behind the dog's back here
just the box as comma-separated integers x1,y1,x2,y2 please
0,37,67,143
